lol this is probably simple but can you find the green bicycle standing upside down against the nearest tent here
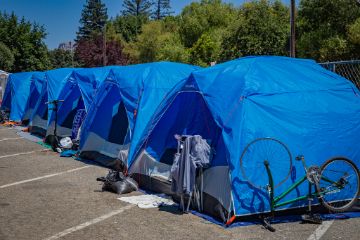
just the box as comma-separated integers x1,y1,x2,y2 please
240,138,360,231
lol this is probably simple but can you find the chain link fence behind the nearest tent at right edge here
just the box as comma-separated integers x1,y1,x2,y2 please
320,60,360,89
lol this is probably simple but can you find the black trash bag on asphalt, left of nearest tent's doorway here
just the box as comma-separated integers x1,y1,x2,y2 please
96,170,138,194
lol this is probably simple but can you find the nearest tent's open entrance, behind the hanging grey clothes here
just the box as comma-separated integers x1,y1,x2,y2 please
129,91,231,221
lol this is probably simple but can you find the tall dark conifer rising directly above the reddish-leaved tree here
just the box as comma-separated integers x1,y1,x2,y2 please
76,0,108,42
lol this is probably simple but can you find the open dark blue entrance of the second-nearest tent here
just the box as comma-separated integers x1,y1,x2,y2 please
80,82,130,167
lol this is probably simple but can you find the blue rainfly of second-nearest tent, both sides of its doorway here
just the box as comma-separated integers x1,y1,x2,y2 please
80,62,199,164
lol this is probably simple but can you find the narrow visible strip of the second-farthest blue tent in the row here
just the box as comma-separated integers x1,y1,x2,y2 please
23,72,45,121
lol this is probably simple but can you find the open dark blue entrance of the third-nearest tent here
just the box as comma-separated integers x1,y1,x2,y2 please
46,82,85,142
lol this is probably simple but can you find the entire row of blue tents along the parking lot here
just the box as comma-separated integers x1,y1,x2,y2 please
2,56,360,220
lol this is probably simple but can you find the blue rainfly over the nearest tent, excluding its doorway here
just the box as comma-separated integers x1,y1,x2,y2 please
128,56,360,216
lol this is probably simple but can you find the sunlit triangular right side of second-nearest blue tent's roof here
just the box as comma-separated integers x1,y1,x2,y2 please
112,62,200,151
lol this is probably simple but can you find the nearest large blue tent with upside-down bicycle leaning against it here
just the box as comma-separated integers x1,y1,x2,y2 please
128,56,360,220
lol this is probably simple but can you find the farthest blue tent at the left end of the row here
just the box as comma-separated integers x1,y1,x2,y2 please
1,72,34,121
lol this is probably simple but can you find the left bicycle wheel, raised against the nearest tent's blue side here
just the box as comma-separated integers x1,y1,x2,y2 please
240,138,292,189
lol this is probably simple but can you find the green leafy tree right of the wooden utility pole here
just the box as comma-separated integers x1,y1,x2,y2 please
297,0,360,61
